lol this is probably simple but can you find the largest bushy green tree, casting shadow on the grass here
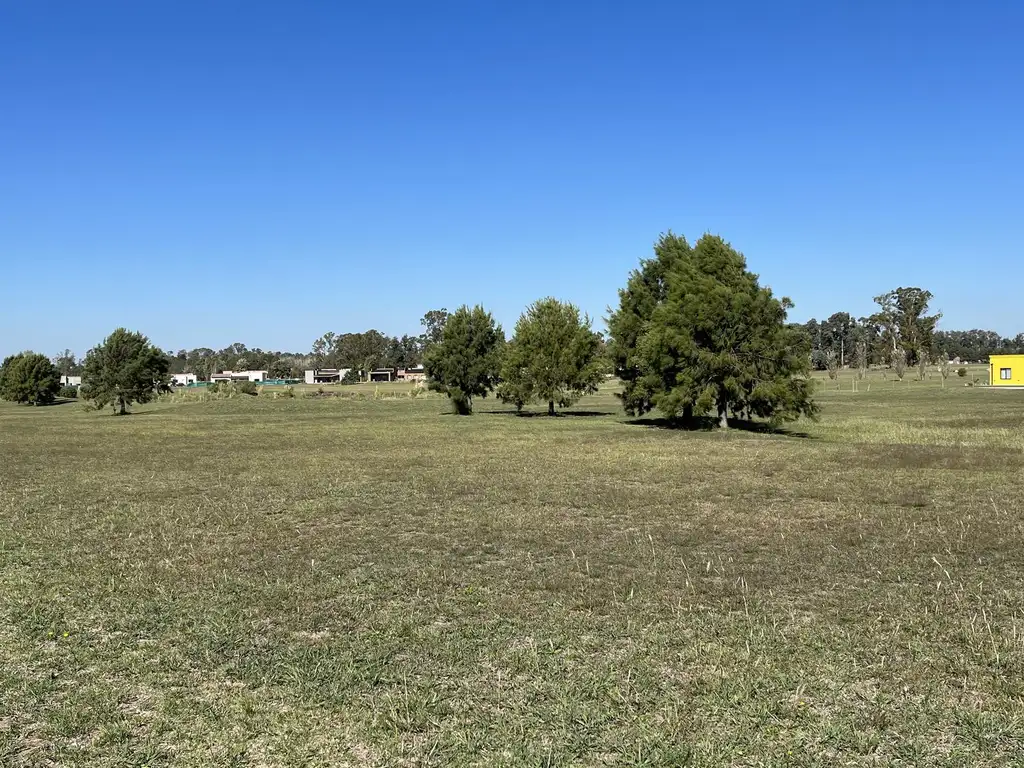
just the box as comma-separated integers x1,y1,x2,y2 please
609,234,816,427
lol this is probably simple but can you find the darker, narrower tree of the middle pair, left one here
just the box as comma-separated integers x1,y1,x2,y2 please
424,306,505,416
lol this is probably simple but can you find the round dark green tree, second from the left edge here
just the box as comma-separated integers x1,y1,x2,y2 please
81,328,170,415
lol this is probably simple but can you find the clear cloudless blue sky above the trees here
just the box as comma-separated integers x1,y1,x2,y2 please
0,0,1024,354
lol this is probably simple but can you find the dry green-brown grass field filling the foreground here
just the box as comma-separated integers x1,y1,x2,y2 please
0,374,1024,768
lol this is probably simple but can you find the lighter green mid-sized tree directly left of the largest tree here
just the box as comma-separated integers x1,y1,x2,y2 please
498,298,604,415
